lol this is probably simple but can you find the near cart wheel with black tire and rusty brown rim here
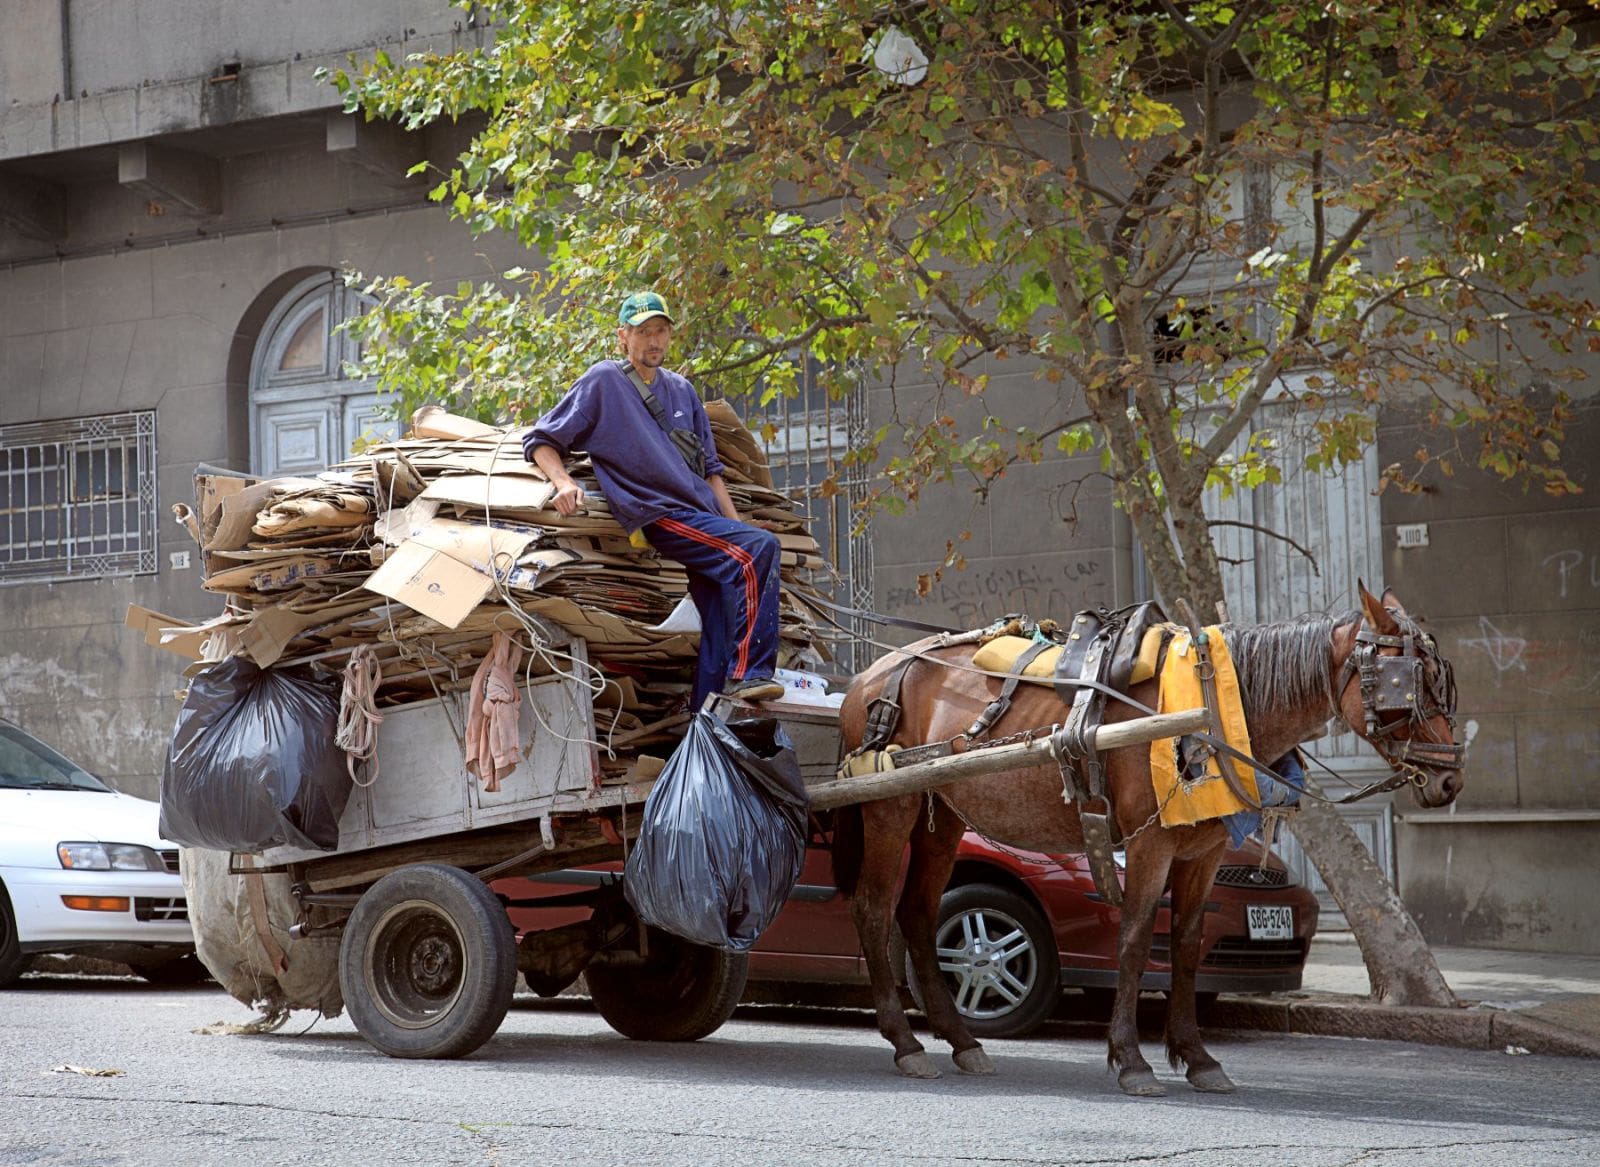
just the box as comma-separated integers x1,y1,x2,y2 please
339,863,517,1058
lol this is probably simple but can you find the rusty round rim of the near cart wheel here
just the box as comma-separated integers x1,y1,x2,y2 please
362,900,467,1029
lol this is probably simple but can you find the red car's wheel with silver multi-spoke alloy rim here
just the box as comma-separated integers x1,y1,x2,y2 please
906,884,1061,1037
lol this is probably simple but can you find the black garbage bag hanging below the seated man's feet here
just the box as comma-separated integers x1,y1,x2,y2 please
622,711,810,952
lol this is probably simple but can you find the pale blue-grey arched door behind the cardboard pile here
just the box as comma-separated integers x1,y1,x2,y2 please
250,272,398,477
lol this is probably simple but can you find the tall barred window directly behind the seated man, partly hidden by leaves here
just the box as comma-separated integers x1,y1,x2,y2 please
736,360,874,674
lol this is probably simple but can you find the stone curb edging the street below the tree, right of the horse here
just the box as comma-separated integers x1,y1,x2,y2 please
1203,997,1600,1058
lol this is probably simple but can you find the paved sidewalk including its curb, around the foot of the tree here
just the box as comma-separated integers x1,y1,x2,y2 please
1206,932,1600,1058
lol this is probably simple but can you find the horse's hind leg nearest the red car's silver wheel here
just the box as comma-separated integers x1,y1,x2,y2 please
894,796,995,1074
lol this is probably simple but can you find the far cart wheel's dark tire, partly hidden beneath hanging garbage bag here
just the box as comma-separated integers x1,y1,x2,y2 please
584,928,750,1042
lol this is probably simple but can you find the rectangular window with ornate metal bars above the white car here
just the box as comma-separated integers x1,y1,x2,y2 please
0,410,155,584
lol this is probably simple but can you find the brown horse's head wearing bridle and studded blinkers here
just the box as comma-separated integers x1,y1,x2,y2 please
1334,584,1466,807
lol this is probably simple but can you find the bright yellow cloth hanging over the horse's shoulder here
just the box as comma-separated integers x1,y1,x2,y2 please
1150,626,1261,826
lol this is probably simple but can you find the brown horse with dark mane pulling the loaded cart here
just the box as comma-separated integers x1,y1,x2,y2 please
834,586,1461,1095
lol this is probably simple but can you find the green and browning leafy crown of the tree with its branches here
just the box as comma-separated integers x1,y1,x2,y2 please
334,0,1600,602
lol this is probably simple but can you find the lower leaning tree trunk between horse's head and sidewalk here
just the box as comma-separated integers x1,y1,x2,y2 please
1290,787,1458,1007
